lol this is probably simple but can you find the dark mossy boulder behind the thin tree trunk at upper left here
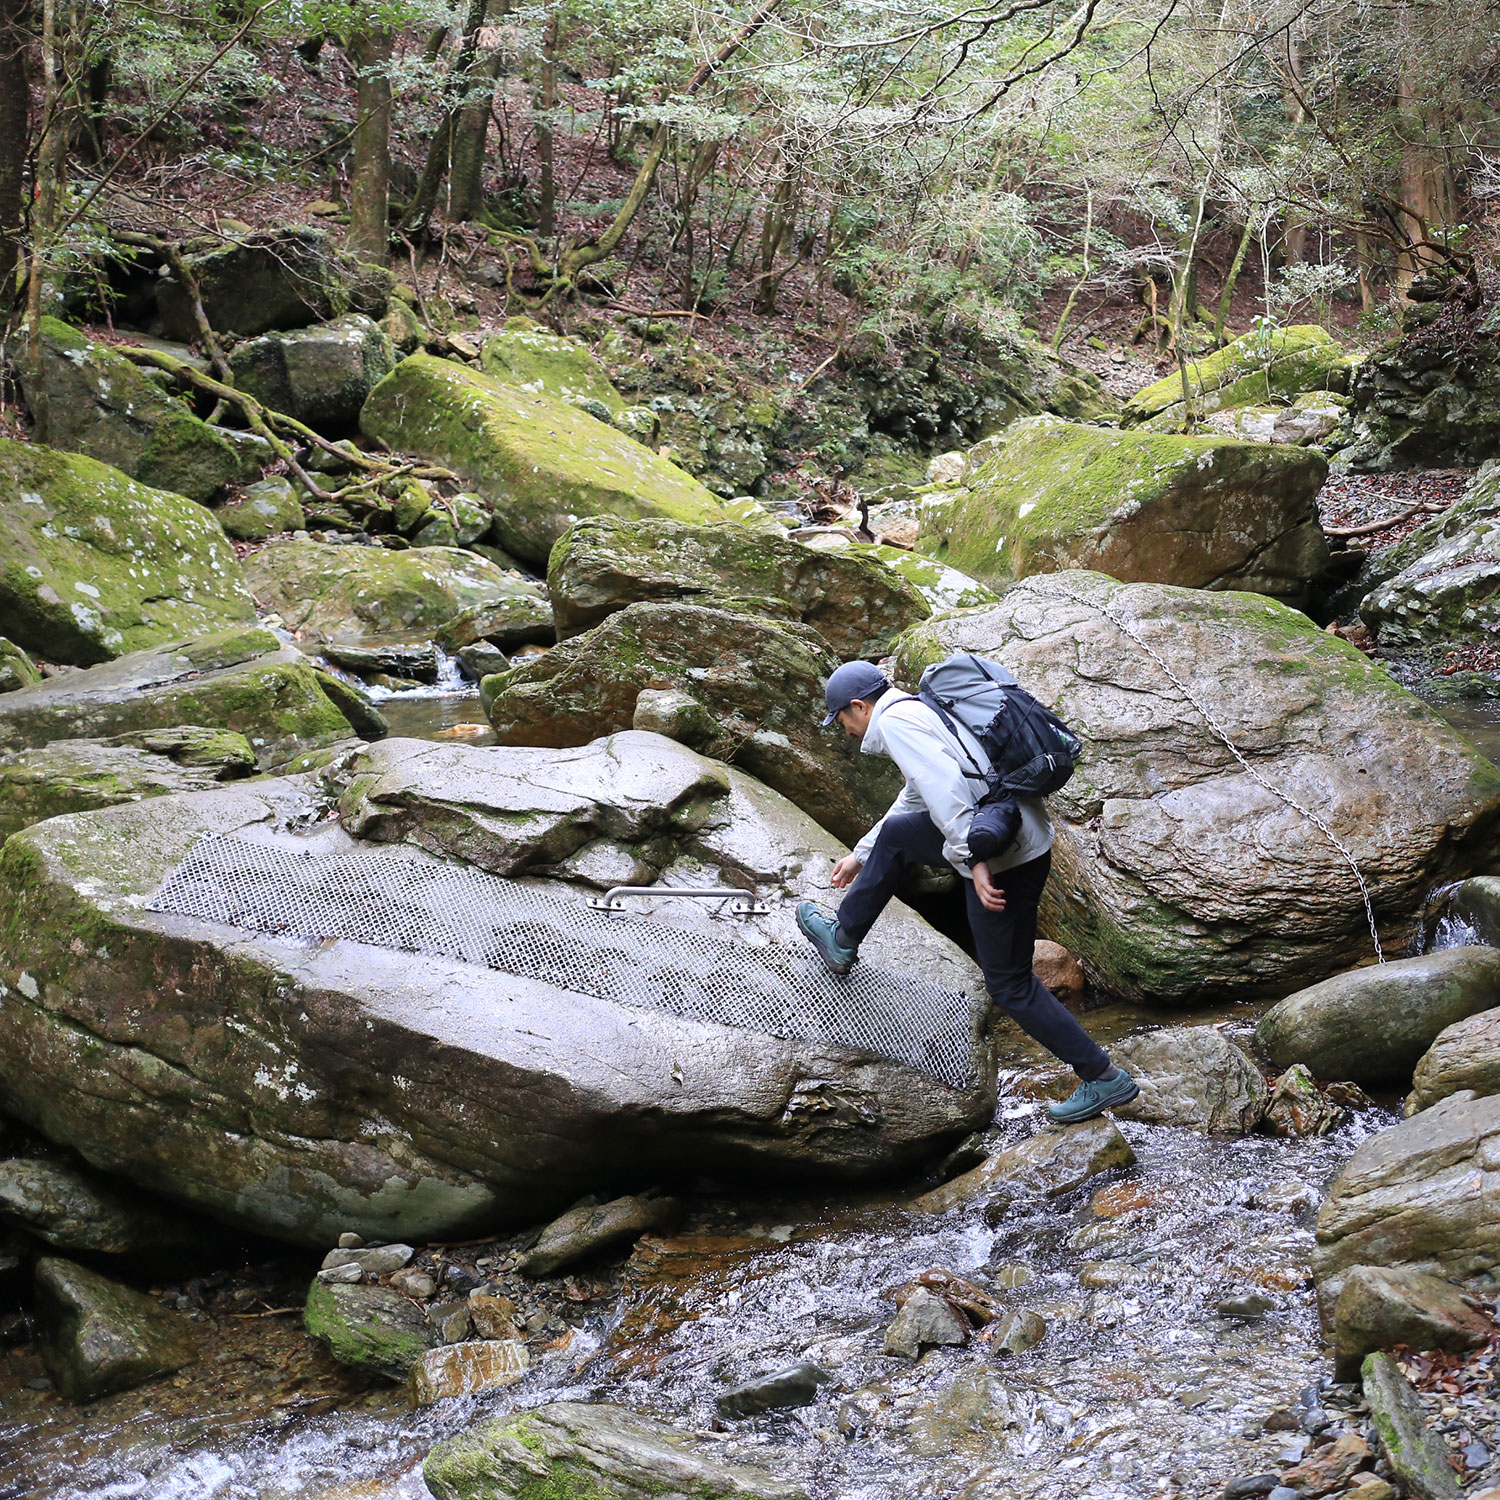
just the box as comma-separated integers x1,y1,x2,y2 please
18,318,243,501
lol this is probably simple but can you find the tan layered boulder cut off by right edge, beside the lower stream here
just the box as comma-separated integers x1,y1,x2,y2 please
1313,1098,1500,1310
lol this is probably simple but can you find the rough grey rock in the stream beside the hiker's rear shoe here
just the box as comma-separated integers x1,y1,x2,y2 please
1110,1026,1266,1136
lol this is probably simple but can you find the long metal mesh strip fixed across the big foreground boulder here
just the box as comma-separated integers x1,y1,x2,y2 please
149,834,972,1089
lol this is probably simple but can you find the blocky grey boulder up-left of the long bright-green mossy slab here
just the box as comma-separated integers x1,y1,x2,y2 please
230,312,396,438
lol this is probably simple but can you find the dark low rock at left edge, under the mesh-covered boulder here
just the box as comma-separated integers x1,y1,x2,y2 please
0,1157,207,1256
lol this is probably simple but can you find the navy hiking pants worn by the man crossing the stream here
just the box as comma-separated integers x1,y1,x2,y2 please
839,813,1112,1080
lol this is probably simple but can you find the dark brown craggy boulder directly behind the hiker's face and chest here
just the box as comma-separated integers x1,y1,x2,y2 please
482,605,900,843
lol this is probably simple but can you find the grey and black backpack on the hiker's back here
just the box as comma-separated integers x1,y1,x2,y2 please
917,651,1083,801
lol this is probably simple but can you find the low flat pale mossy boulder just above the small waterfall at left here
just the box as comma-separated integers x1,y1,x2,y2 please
245,540,552,647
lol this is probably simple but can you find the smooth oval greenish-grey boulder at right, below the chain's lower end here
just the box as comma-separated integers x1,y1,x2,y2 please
1256,947,1500,1083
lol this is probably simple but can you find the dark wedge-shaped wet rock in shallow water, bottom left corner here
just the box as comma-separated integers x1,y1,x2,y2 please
36,1257,198,1401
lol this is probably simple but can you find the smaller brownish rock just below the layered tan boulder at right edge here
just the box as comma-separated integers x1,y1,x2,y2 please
1334,1266,1494,1380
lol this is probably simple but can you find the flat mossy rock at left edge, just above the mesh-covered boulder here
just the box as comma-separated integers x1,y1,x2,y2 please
0,726,255,839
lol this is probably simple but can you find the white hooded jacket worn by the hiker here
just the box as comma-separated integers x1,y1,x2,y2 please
854,687,1052,881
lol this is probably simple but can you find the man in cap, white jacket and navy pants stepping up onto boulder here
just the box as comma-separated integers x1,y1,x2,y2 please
797,662,1140,1124
